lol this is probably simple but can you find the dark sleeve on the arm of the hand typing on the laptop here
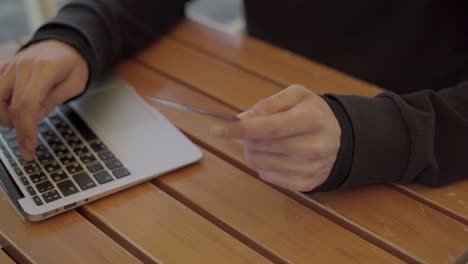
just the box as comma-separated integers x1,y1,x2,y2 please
22,0,188,82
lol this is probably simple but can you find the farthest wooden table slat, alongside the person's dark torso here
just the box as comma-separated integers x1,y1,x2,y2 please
171,20,382,96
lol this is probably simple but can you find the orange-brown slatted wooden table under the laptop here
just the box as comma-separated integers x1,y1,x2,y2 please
0,21,468,264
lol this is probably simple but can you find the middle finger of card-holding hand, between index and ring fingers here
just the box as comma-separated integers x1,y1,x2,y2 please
241,133,340,160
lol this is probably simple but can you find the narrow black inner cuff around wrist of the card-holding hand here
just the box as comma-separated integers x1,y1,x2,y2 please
306,94,354,194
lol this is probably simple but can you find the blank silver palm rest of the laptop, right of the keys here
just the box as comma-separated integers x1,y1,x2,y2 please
71,78,201,174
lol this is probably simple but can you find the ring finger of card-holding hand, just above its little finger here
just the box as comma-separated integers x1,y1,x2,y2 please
245,150,322,177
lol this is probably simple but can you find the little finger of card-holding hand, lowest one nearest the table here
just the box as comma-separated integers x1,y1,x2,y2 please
258,171,321,192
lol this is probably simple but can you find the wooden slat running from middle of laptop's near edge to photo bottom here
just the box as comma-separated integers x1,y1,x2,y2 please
79,182,270,263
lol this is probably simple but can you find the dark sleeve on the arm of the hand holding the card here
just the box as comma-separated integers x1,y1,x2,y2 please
319,82,468,190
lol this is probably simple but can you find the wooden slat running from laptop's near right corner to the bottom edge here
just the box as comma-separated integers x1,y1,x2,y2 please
118,64,406,263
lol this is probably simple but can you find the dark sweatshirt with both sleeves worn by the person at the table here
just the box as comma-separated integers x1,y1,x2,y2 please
22,0,468,191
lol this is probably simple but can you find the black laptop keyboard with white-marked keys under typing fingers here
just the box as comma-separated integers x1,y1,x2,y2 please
0,105,130,206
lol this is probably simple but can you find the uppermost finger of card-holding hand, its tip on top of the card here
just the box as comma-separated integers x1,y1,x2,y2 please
237,84,317,119
